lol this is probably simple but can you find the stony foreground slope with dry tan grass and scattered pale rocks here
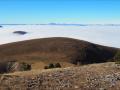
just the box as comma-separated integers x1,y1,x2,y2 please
0,62,120,90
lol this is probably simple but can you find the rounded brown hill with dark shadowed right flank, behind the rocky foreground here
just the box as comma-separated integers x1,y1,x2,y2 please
0,37,118,69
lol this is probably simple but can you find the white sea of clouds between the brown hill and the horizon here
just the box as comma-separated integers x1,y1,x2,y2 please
0,25,120,48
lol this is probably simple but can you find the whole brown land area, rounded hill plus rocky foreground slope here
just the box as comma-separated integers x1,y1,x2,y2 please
0,37,120,90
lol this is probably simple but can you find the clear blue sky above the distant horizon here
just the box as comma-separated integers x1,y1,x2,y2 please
0,0,120,24
